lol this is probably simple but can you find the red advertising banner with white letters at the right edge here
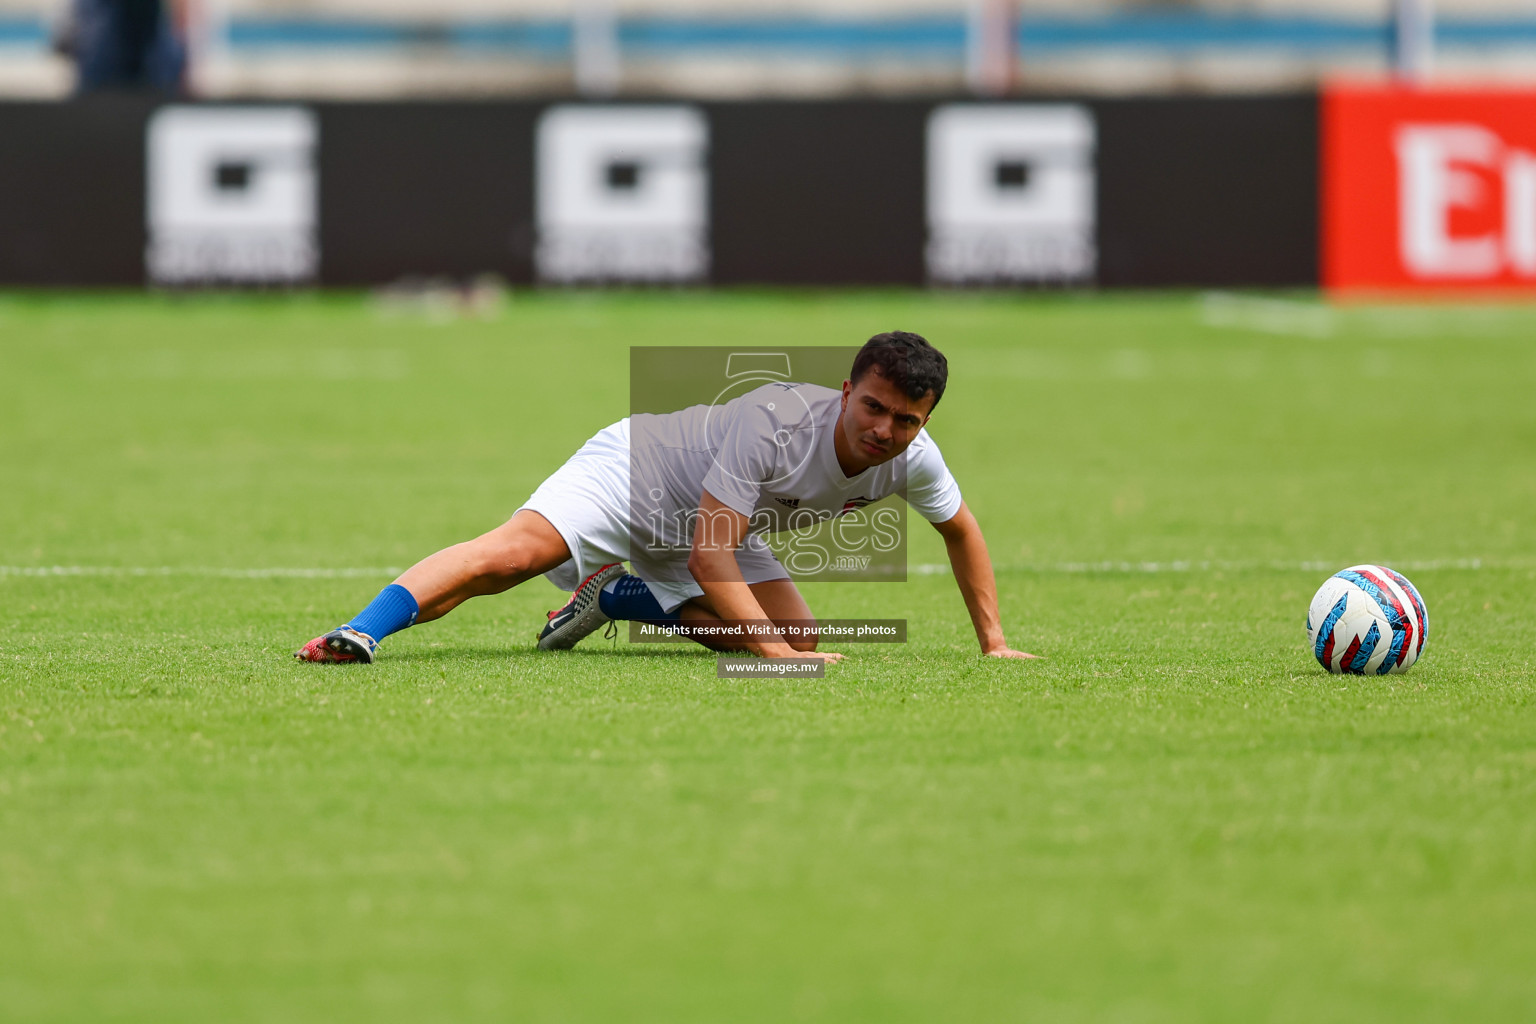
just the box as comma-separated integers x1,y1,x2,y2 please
1321,86,1536,293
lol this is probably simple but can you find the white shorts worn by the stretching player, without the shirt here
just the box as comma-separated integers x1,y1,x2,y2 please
518,419,790,611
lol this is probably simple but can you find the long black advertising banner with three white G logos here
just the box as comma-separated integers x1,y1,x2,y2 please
0,95,1318,289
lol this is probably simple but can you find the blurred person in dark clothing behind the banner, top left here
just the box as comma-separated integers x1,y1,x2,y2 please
55,0,186,94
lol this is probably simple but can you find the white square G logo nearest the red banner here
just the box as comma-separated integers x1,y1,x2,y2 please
928,104,1098,284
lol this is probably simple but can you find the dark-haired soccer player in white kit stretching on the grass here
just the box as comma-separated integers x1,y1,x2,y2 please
295,332,1034,663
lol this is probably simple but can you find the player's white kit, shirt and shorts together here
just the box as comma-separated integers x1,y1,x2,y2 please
524,382,960,608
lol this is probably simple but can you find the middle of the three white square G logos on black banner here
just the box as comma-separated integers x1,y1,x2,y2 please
535,106,710,282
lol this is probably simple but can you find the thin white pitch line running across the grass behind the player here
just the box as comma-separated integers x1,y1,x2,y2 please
0,559,1517,579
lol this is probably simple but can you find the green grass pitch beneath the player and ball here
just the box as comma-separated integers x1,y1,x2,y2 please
0,292,1536,1024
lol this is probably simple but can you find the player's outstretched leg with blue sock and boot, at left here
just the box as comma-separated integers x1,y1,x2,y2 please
293,508,571,665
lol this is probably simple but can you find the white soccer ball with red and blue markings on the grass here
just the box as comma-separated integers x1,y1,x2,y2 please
1307,565,1430,676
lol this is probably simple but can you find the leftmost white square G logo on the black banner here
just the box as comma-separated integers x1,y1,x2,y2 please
144,106,319,284
